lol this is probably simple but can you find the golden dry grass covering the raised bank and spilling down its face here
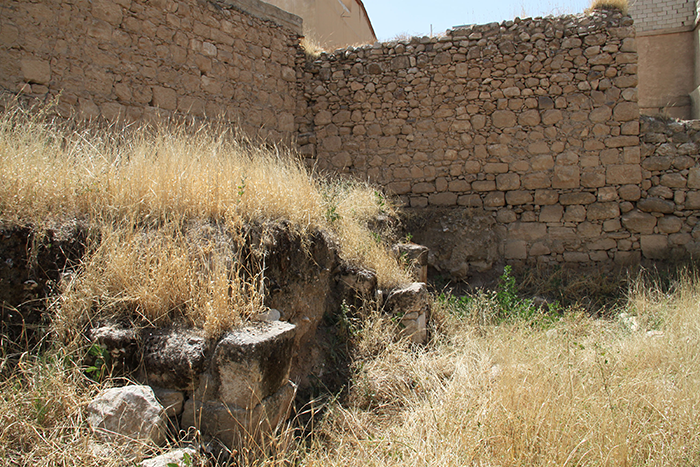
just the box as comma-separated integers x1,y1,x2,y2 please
0,99,408,335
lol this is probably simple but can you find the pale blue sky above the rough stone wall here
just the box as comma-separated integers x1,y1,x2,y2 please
363,0,591,41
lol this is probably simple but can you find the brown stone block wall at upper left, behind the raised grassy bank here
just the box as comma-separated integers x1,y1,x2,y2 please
0,0,301,140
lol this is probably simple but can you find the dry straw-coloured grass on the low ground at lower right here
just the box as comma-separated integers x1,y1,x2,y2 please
304,277,700,466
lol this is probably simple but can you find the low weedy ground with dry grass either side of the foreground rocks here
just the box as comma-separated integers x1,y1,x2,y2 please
0,266,700,466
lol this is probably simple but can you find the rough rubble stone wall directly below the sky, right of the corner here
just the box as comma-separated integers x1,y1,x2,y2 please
300,12,660,270
